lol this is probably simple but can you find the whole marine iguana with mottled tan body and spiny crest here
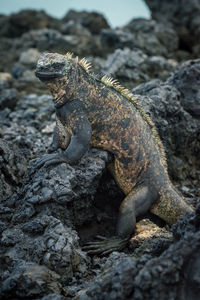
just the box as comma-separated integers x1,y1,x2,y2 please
35,53,192,254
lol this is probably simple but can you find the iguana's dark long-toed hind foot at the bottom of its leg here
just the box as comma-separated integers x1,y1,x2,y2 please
83,236,129,256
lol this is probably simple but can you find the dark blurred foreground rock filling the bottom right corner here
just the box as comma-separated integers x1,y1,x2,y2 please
77,212,200,300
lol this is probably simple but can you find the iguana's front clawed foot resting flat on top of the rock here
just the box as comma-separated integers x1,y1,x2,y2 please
32,153,68,169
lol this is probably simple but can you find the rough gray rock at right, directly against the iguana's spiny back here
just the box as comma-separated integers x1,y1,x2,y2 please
133,80,200,181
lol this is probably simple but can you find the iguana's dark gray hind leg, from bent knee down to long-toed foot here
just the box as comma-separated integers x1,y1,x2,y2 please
83,185,154,255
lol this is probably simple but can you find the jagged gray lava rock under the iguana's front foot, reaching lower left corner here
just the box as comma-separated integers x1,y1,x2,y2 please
0,149,108,297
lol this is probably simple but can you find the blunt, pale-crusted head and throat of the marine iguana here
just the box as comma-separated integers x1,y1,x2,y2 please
35,53,77,105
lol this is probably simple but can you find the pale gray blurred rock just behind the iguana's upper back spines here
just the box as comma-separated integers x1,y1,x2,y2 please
101,48,177,88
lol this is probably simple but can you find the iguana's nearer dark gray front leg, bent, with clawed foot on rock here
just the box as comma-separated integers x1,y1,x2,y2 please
34,112,92,168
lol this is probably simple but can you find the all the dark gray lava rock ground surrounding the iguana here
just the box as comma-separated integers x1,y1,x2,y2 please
0,0,200,300
